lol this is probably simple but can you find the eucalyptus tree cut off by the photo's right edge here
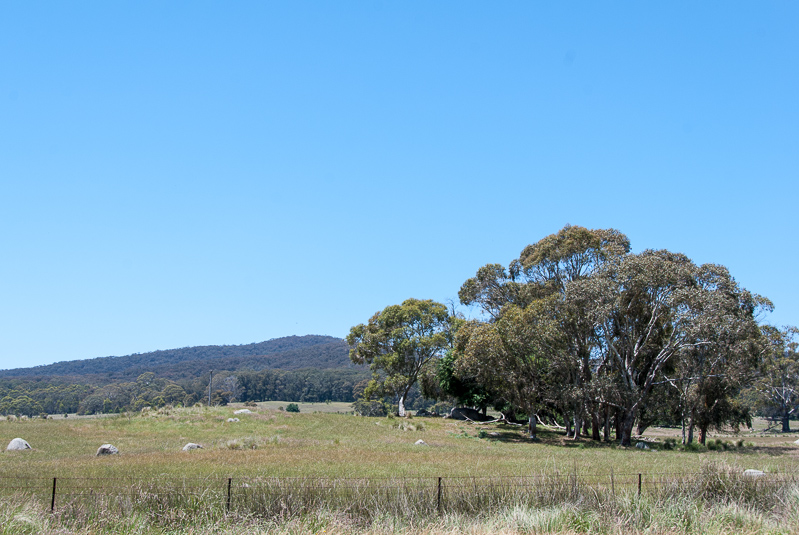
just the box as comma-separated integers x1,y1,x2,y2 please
755,326,799,433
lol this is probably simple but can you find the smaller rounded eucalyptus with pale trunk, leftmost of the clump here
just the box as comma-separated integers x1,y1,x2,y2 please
347,299,455,416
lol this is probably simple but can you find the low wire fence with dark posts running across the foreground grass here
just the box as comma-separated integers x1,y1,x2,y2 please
0,469,799,517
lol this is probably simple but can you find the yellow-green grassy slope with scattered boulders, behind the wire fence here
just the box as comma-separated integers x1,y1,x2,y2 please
0,402,799,478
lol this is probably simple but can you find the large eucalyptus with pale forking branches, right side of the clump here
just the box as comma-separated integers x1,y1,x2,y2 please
568,250,759,446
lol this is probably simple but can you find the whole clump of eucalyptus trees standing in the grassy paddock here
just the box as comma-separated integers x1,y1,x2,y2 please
347,226,799,445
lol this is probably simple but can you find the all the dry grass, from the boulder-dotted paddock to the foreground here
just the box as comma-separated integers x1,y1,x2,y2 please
0,404,799,535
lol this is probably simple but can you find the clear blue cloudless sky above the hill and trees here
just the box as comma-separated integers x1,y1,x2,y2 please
0,0,799,368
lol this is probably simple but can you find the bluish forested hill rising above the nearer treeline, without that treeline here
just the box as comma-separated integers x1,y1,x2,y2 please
0,335,352,378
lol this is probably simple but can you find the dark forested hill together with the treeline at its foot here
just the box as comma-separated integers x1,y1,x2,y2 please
0,335,370,416
